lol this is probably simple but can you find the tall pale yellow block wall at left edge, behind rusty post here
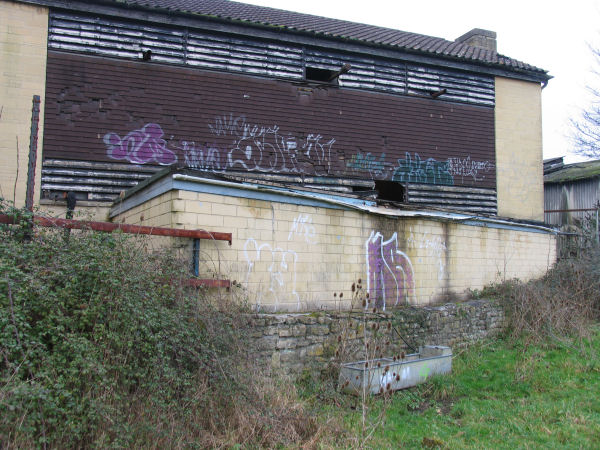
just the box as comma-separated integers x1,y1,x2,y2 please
0,0,48,207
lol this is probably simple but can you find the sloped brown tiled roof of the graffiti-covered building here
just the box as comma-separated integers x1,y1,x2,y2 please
114,0,550,78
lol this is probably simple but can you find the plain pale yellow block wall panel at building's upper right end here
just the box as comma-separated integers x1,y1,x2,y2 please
495,77,544,221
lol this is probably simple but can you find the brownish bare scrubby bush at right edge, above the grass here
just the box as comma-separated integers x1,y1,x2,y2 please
482,247,600,340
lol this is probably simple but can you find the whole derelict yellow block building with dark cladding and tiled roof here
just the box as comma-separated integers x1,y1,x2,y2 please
0,0,556,311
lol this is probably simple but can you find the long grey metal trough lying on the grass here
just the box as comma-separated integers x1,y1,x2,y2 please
339,345,452,395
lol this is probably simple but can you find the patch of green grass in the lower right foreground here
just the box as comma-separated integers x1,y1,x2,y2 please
332,327,600,449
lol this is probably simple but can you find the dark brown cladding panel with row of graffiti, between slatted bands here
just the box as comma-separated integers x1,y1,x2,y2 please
44,51,496,187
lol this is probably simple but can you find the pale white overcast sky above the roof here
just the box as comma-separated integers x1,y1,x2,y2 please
240,0,600,163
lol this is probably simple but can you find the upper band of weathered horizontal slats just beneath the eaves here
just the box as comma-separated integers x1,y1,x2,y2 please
48,11,494,106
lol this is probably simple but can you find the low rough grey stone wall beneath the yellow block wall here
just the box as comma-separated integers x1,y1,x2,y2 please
251,300,504,375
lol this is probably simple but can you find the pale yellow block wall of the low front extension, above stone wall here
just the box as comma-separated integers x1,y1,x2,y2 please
115,191,555,311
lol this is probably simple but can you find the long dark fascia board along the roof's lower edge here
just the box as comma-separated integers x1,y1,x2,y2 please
17,0,551,83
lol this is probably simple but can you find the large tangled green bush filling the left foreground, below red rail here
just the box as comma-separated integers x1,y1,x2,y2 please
0,203,317,448
